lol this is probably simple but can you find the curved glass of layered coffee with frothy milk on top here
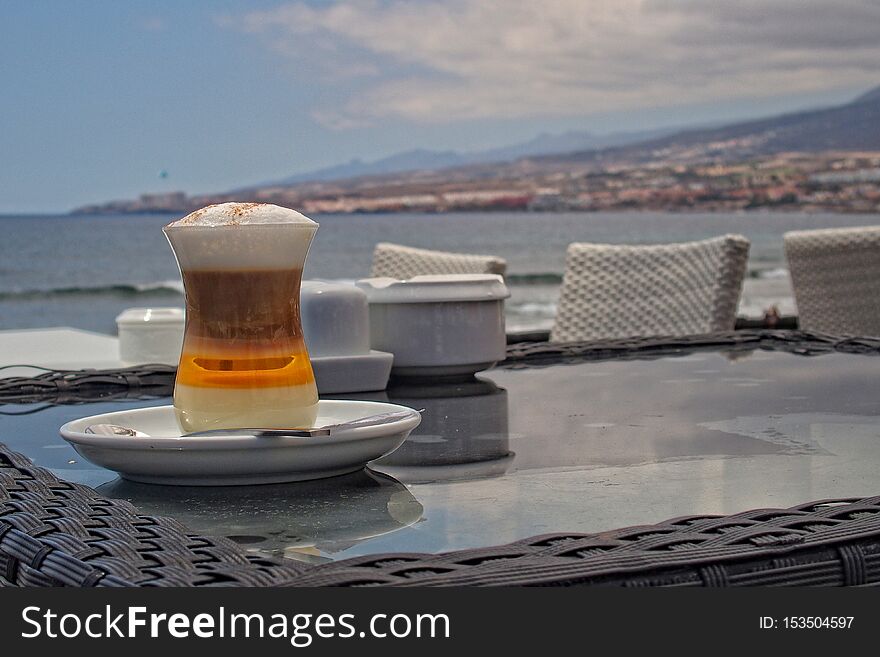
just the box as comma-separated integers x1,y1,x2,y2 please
163,203,318,433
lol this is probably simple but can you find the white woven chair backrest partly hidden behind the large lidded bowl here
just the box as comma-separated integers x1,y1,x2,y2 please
370,242,507,279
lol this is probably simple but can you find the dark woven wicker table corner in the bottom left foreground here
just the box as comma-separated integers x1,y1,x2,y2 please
0,444,303,586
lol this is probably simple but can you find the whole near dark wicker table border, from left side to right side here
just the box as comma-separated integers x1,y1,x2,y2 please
0,438,880,587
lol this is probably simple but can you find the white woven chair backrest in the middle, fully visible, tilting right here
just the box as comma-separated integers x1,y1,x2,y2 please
550,235,749,342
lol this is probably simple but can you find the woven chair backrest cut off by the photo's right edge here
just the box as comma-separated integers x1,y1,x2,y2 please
784,226,880,335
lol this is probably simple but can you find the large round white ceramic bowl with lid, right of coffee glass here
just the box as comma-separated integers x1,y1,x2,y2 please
357,274,510,377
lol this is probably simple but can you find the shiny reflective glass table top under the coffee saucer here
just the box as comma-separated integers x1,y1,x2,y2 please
0,350,880,562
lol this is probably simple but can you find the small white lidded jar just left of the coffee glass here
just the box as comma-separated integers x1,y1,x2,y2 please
116,308,186,365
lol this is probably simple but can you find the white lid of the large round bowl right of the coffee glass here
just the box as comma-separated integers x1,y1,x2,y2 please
357,274,510,303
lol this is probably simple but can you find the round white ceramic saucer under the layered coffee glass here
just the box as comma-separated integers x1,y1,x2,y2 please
61,400,421,486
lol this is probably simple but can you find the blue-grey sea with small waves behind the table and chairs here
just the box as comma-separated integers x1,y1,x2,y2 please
0,212,880,333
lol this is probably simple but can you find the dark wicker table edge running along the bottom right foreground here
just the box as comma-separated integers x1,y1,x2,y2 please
286,496,880,587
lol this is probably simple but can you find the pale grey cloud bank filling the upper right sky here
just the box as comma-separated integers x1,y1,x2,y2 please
235,0,880,127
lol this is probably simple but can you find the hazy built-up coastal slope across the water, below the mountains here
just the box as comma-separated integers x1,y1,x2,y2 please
71,151,880,215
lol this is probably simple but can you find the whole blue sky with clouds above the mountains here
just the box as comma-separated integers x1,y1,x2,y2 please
0,0,880,213
